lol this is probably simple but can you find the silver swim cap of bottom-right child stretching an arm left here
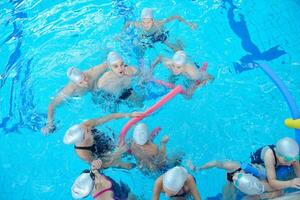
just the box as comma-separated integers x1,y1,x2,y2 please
233,173,265,195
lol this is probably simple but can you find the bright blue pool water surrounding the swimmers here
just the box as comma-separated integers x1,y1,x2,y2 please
0,0,300,200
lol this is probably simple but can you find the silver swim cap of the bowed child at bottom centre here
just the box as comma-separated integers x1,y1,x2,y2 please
163,166,188,193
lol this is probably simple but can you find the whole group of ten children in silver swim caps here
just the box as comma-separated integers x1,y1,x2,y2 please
42,8,300,200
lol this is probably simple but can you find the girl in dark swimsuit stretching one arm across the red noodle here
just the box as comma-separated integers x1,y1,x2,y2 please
64,112,141,169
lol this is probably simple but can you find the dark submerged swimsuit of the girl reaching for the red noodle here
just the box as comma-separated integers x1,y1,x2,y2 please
91,129,115,158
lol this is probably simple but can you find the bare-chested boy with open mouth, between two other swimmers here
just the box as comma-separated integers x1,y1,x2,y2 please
93,52,143,111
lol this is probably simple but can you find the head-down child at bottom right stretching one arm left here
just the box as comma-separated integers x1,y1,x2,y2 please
188,160,281,199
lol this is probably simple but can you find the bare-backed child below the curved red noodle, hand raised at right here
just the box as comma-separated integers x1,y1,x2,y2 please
130,123,181,172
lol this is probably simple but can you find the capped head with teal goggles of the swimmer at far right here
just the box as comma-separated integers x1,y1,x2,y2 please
276,137,299,166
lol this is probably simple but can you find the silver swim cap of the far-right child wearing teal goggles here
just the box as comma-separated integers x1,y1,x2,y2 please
276,137,299,159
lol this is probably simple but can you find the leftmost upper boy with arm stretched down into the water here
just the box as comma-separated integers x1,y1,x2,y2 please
41,63,107,134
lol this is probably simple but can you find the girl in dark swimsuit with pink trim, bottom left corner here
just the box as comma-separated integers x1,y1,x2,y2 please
71,160,136,200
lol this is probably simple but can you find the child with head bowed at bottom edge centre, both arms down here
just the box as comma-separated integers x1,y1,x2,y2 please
152,166,201,200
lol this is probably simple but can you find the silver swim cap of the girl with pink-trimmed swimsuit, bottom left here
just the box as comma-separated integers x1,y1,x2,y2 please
71,170,94,199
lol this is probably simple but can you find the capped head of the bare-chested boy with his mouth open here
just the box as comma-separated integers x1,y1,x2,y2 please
107,51,125,76
